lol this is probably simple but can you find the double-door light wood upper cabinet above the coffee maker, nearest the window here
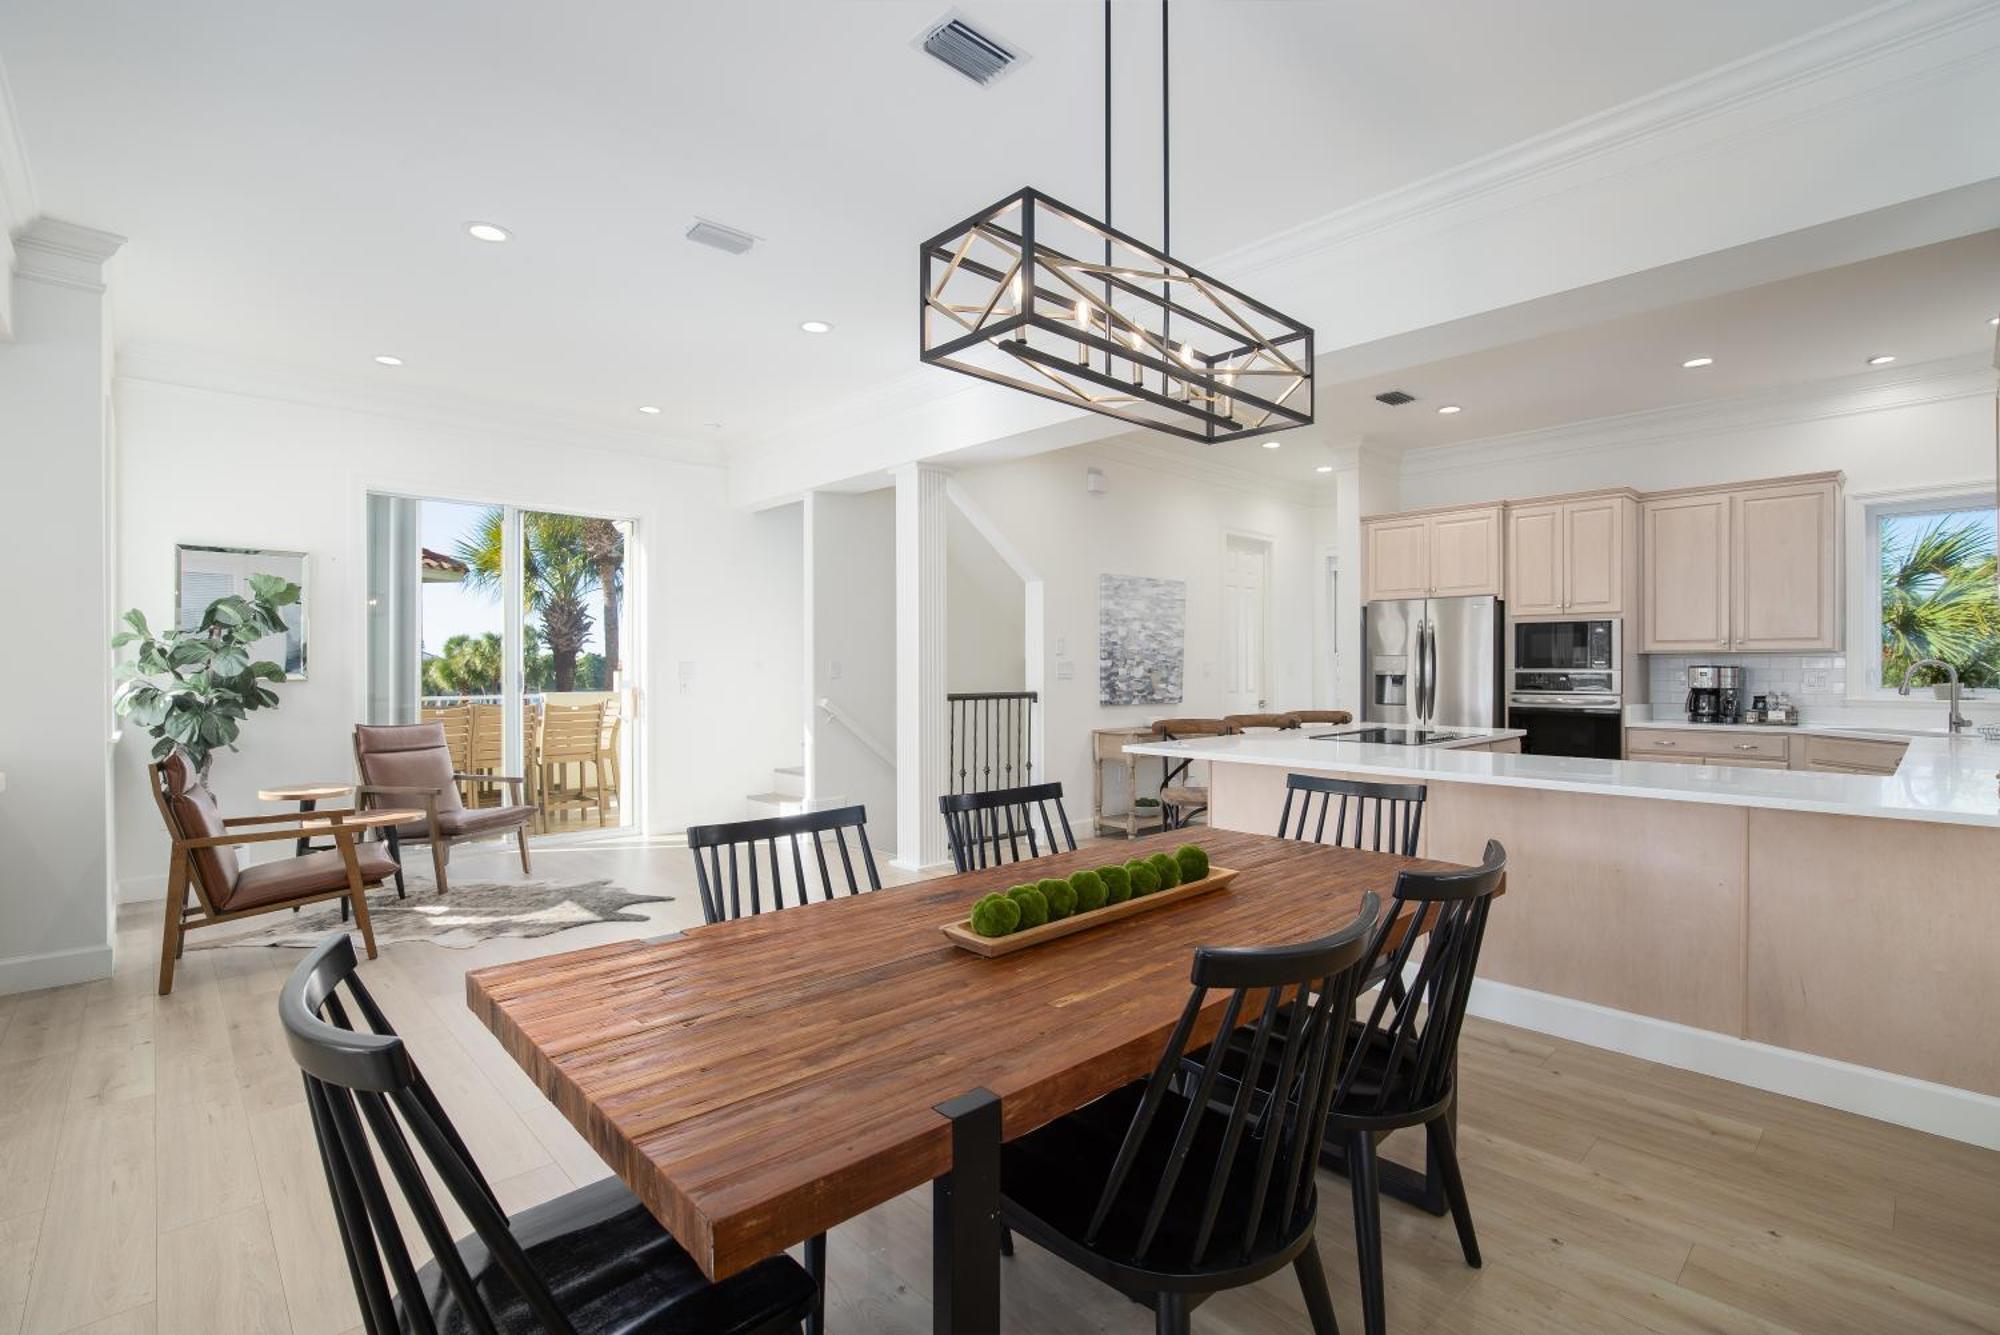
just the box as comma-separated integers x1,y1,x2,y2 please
1640,476,1840,654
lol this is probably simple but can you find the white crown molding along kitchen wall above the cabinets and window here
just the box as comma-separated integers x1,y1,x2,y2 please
1400,354,2000,478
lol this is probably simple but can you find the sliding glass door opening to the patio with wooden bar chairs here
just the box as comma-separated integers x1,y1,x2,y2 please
368,494,638,831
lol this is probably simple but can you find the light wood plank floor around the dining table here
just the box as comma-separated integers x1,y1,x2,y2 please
0,837,2000,1335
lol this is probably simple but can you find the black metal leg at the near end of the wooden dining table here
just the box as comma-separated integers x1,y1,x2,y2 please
930,1089,1000,1335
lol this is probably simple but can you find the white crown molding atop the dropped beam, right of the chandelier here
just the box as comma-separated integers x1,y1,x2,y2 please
1202,0,2000,276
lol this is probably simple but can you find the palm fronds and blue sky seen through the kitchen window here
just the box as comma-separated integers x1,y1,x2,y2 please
1882,516,2000,685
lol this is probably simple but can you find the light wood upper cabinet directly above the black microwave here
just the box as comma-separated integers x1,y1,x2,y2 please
1506,494,1634,618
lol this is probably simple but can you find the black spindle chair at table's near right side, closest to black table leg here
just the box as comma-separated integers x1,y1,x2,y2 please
1000,893,1380,1335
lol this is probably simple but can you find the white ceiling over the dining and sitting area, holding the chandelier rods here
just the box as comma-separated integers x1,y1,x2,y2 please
0,0,1898,444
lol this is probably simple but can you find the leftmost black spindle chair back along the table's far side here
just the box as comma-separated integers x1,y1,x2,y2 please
688,807,882,923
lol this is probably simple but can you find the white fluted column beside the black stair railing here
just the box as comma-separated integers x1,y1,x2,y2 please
894,464,950,871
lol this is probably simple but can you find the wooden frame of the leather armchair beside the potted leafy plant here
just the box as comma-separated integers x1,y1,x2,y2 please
146,765,394,997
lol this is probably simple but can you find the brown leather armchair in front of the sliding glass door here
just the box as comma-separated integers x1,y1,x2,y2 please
354,723,534,895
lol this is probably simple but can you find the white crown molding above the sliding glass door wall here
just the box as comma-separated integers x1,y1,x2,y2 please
114,342,724,470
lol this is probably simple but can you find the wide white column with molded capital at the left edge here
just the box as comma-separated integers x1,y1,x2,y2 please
0,218,125,993
